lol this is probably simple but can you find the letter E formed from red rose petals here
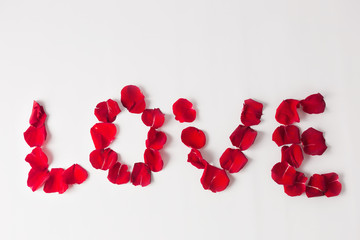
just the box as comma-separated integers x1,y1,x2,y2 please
271,93,341,198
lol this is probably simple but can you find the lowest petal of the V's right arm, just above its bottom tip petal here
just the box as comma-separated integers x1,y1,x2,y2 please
220,148,248,173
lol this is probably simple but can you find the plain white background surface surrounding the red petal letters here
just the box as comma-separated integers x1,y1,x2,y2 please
0,0,360,240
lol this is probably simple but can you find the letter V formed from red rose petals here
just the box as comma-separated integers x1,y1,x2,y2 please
173,98,263,193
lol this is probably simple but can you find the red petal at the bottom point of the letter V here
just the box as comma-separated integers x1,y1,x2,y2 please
200,164,230,193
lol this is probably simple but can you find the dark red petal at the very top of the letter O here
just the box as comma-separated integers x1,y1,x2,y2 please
121,85,146,113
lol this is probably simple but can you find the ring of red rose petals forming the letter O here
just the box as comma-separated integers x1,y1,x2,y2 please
89,85,167,187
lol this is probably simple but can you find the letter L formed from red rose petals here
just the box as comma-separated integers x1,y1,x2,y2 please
24,101,88,194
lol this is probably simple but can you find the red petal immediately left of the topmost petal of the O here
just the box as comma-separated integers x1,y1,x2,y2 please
94,99,121,123
